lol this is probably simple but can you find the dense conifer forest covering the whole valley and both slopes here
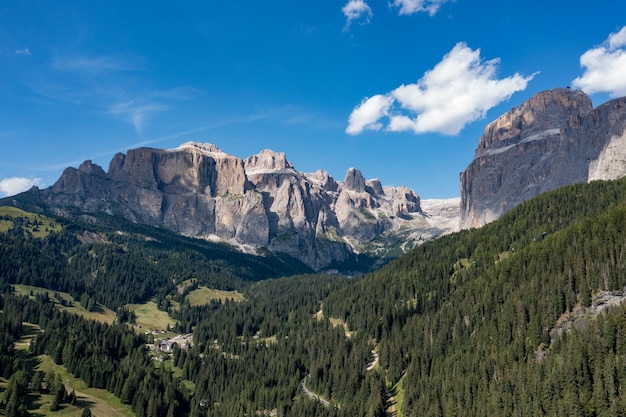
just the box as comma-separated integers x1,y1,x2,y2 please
0,180,626,417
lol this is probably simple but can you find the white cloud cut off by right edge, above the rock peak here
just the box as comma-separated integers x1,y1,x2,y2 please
572,26,626,97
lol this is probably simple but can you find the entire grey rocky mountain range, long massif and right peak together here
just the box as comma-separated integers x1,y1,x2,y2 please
11,88,626,270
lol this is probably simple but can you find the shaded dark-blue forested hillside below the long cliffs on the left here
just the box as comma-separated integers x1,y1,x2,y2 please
0,207,310,310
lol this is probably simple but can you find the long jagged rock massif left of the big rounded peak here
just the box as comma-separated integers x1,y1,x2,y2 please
14,142,459,270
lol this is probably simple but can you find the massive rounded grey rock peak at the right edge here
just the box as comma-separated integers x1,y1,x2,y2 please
460,88,626,228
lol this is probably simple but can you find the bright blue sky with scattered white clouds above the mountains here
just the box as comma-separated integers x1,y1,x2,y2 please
0,0,626,198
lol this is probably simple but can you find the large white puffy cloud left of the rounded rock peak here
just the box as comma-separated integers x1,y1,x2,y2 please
346,42,534,135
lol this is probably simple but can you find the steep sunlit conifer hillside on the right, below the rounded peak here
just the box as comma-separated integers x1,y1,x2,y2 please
324,180,626,416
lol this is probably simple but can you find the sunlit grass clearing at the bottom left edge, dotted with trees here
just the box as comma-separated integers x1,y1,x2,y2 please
35,355,135,417
